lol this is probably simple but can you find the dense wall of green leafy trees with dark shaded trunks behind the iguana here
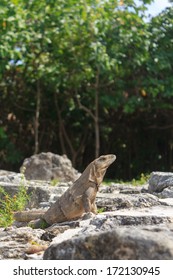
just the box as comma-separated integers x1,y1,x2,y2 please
0,0,173,179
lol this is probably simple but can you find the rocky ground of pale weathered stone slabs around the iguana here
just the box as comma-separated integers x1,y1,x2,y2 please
0,154,173,260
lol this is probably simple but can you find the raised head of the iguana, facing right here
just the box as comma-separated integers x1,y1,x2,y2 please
89,154,116,186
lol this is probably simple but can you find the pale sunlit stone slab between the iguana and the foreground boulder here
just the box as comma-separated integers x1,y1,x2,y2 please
42,206,173,247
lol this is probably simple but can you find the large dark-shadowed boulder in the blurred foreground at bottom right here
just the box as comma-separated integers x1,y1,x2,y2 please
43,223,173,260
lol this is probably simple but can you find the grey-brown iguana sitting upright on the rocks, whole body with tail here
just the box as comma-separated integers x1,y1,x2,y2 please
14,154,116,227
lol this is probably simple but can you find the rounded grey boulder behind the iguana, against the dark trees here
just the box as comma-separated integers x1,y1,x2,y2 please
21,152,79,182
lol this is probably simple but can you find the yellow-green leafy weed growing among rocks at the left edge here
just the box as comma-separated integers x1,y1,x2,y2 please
0,175,29,227
